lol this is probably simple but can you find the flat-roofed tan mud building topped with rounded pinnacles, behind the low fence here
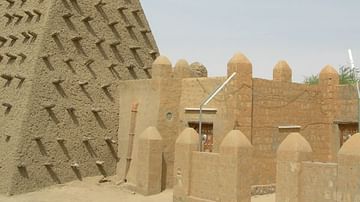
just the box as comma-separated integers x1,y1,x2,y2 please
117,53,357,187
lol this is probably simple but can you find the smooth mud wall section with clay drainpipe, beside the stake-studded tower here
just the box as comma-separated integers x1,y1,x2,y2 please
117,80,160,184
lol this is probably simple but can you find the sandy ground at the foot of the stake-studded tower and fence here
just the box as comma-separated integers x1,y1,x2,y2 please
0,177,275,202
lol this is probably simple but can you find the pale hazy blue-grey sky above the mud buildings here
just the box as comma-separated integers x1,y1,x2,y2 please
141,0,360,82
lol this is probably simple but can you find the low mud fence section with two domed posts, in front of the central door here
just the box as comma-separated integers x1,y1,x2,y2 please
173,128,253,202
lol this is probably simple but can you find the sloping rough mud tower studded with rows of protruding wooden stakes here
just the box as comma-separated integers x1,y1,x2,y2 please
0,0,158,194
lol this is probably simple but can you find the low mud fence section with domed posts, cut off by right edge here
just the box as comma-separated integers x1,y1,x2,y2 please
276,133,360,202
